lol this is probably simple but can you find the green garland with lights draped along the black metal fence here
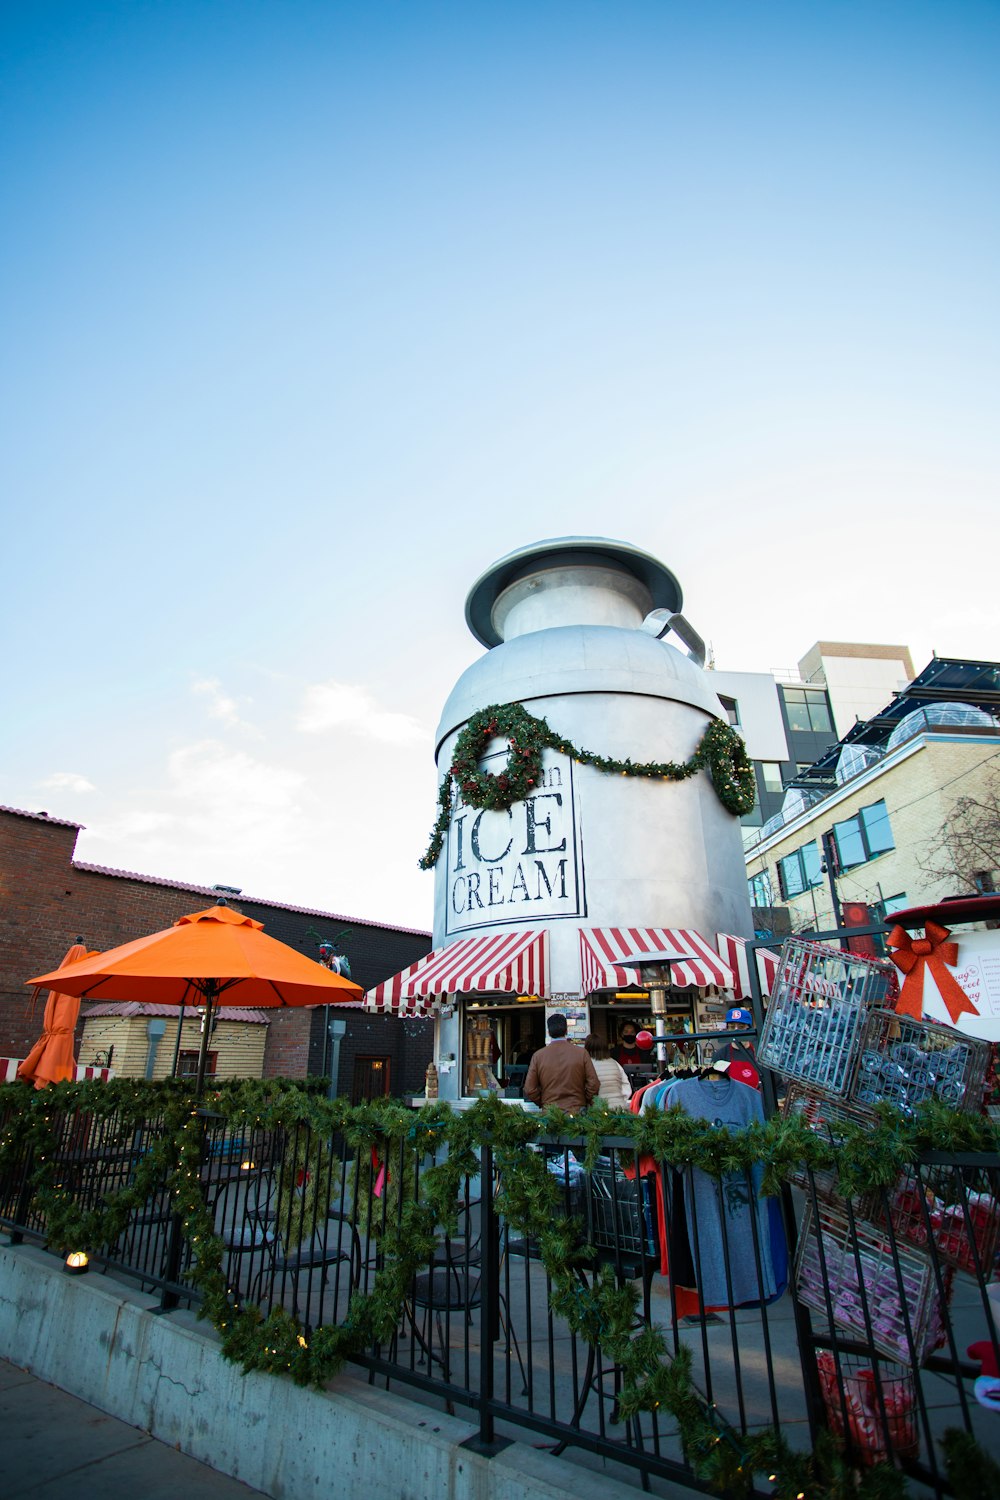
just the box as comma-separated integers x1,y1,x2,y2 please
0,1080,1000,1500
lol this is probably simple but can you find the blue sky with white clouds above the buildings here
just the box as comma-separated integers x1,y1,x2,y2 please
0,0,1000,926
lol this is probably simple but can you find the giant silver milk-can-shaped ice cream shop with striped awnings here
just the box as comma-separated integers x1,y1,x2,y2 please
366,537,754,1101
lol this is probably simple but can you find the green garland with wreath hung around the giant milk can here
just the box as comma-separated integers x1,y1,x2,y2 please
420,704,757,870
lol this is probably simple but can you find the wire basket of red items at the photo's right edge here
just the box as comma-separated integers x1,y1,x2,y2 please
871,1167,1000,1281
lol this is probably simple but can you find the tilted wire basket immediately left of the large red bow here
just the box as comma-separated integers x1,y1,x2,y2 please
757,938,898,1094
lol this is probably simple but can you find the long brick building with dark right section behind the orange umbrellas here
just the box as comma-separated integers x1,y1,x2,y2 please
0,807,432,1097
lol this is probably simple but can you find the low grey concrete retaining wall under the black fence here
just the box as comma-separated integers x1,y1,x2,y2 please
0,1245,650,1500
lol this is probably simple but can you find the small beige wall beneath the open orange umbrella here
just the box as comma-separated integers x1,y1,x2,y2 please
78,1016,267,1079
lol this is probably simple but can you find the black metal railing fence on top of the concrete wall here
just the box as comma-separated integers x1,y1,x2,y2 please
0,1104,1000,1496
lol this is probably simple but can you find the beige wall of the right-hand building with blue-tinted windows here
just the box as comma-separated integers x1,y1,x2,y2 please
747,734,997,930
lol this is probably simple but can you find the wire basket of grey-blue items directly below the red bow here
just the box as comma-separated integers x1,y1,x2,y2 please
850,1010,990,1115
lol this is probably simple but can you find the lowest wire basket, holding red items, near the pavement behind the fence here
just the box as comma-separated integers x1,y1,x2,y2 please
816,1349,921,1467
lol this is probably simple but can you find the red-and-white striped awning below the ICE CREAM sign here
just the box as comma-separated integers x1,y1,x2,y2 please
364,930,549,1016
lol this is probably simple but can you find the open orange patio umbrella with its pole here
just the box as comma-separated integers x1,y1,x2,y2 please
27,906,364,1092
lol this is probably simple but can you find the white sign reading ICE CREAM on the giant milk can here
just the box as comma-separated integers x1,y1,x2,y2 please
445,749,586,936
